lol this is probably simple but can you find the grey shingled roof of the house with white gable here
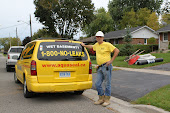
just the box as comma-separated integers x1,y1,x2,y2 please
105,26,156,39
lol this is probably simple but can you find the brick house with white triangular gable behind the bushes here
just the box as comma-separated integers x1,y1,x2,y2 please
105,26,158,45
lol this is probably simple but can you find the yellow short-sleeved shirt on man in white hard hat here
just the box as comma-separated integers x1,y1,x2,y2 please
93,42,116,65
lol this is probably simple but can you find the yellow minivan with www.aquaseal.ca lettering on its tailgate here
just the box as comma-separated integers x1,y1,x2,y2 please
14,39,92,98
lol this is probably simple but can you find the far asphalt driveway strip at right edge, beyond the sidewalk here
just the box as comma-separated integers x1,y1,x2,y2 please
145,63,170,71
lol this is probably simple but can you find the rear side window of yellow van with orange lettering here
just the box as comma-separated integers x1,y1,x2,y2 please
22,42,35,59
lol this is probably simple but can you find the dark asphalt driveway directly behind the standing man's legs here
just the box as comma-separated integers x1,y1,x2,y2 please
93,70,170,101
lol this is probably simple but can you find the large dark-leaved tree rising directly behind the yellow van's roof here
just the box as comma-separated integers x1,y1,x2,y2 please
34,0,94,38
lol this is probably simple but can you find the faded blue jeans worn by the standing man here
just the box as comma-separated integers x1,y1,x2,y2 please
95,64,113,96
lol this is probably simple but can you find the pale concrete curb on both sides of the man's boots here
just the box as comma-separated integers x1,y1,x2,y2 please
83,89,170,113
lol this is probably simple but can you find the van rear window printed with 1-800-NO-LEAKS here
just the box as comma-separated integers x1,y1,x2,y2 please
37,42,88,61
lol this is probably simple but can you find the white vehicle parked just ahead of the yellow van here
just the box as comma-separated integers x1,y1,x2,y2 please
6,46,24,72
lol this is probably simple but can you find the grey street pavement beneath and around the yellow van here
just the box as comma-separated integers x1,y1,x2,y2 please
0,54,113,113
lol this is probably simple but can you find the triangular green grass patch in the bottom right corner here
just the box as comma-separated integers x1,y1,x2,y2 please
132,84,170,111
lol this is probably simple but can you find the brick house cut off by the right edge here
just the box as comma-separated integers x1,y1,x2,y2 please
157,24,170,50
